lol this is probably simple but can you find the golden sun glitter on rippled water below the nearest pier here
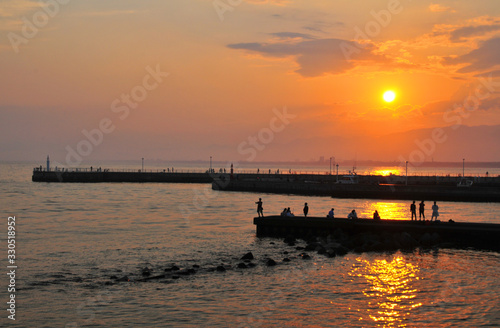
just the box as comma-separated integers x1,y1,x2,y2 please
350,256,422,327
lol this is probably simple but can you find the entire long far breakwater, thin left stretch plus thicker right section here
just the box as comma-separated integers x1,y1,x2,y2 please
32,167,500,202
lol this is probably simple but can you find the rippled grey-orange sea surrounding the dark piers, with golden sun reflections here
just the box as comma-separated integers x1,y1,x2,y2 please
0,162,500,327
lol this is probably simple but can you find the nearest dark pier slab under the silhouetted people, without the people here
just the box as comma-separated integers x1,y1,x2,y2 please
254,216,500,257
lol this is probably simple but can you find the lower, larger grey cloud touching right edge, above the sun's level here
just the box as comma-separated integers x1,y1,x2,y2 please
445,37,500,73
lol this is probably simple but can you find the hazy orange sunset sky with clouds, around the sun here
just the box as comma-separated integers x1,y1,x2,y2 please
0,0,500,166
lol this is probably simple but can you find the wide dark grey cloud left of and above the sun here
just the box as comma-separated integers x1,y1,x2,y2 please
227,37,387,77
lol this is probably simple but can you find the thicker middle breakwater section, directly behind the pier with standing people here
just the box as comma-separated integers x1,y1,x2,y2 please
212,174,500,202
